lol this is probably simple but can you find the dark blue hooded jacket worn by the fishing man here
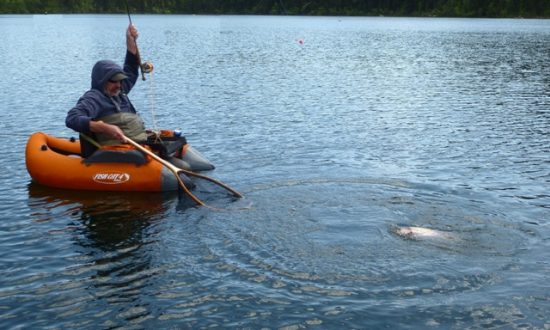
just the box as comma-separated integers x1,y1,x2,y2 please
65,51,139,133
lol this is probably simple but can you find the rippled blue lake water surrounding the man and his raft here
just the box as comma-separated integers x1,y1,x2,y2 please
0,15,550,330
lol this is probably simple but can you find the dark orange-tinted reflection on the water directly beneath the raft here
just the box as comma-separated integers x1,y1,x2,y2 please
28,183,173,251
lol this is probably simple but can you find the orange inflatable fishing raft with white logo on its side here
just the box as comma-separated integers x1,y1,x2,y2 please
25,132,213,192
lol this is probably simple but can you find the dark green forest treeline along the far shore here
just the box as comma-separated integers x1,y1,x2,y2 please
0,0,550,18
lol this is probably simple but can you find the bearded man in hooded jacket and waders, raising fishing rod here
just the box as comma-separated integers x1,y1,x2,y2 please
65,24,214,175
